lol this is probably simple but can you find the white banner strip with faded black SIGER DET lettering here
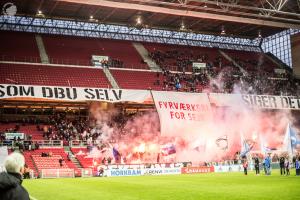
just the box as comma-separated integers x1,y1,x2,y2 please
209,93,300,110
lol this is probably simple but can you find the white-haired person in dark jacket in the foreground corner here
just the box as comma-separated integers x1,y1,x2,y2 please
0,153,30,200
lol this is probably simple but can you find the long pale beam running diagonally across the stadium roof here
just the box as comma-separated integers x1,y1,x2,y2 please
58,0,300,29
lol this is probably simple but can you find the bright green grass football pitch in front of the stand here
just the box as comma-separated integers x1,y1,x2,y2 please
23,171,300,200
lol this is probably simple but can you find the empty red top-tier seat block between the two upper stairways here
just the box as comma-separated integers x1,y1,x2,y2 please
42,35,148,69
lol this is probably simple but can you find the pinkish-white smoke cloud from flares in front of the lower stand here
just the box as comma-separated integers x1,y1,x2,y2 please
86,68,295,164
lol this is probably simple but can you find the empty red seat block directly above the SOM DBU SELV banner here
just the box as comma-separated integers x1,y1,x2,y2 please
0,64,110,88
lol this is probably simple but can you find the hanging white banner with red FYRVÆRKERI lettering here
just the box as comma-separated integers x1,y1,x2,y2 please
152,91,212,136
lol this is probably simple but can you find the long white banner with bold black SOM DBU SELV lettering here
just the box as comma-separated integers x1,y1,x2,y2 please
0,84,151,103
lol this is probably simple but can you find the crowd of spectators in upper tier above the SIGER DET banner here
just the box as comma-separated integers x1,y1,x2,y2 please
150,50,300,96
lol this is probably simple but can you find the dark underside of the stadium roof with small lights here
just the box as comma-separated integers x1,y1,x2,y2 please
4,0,300,38
